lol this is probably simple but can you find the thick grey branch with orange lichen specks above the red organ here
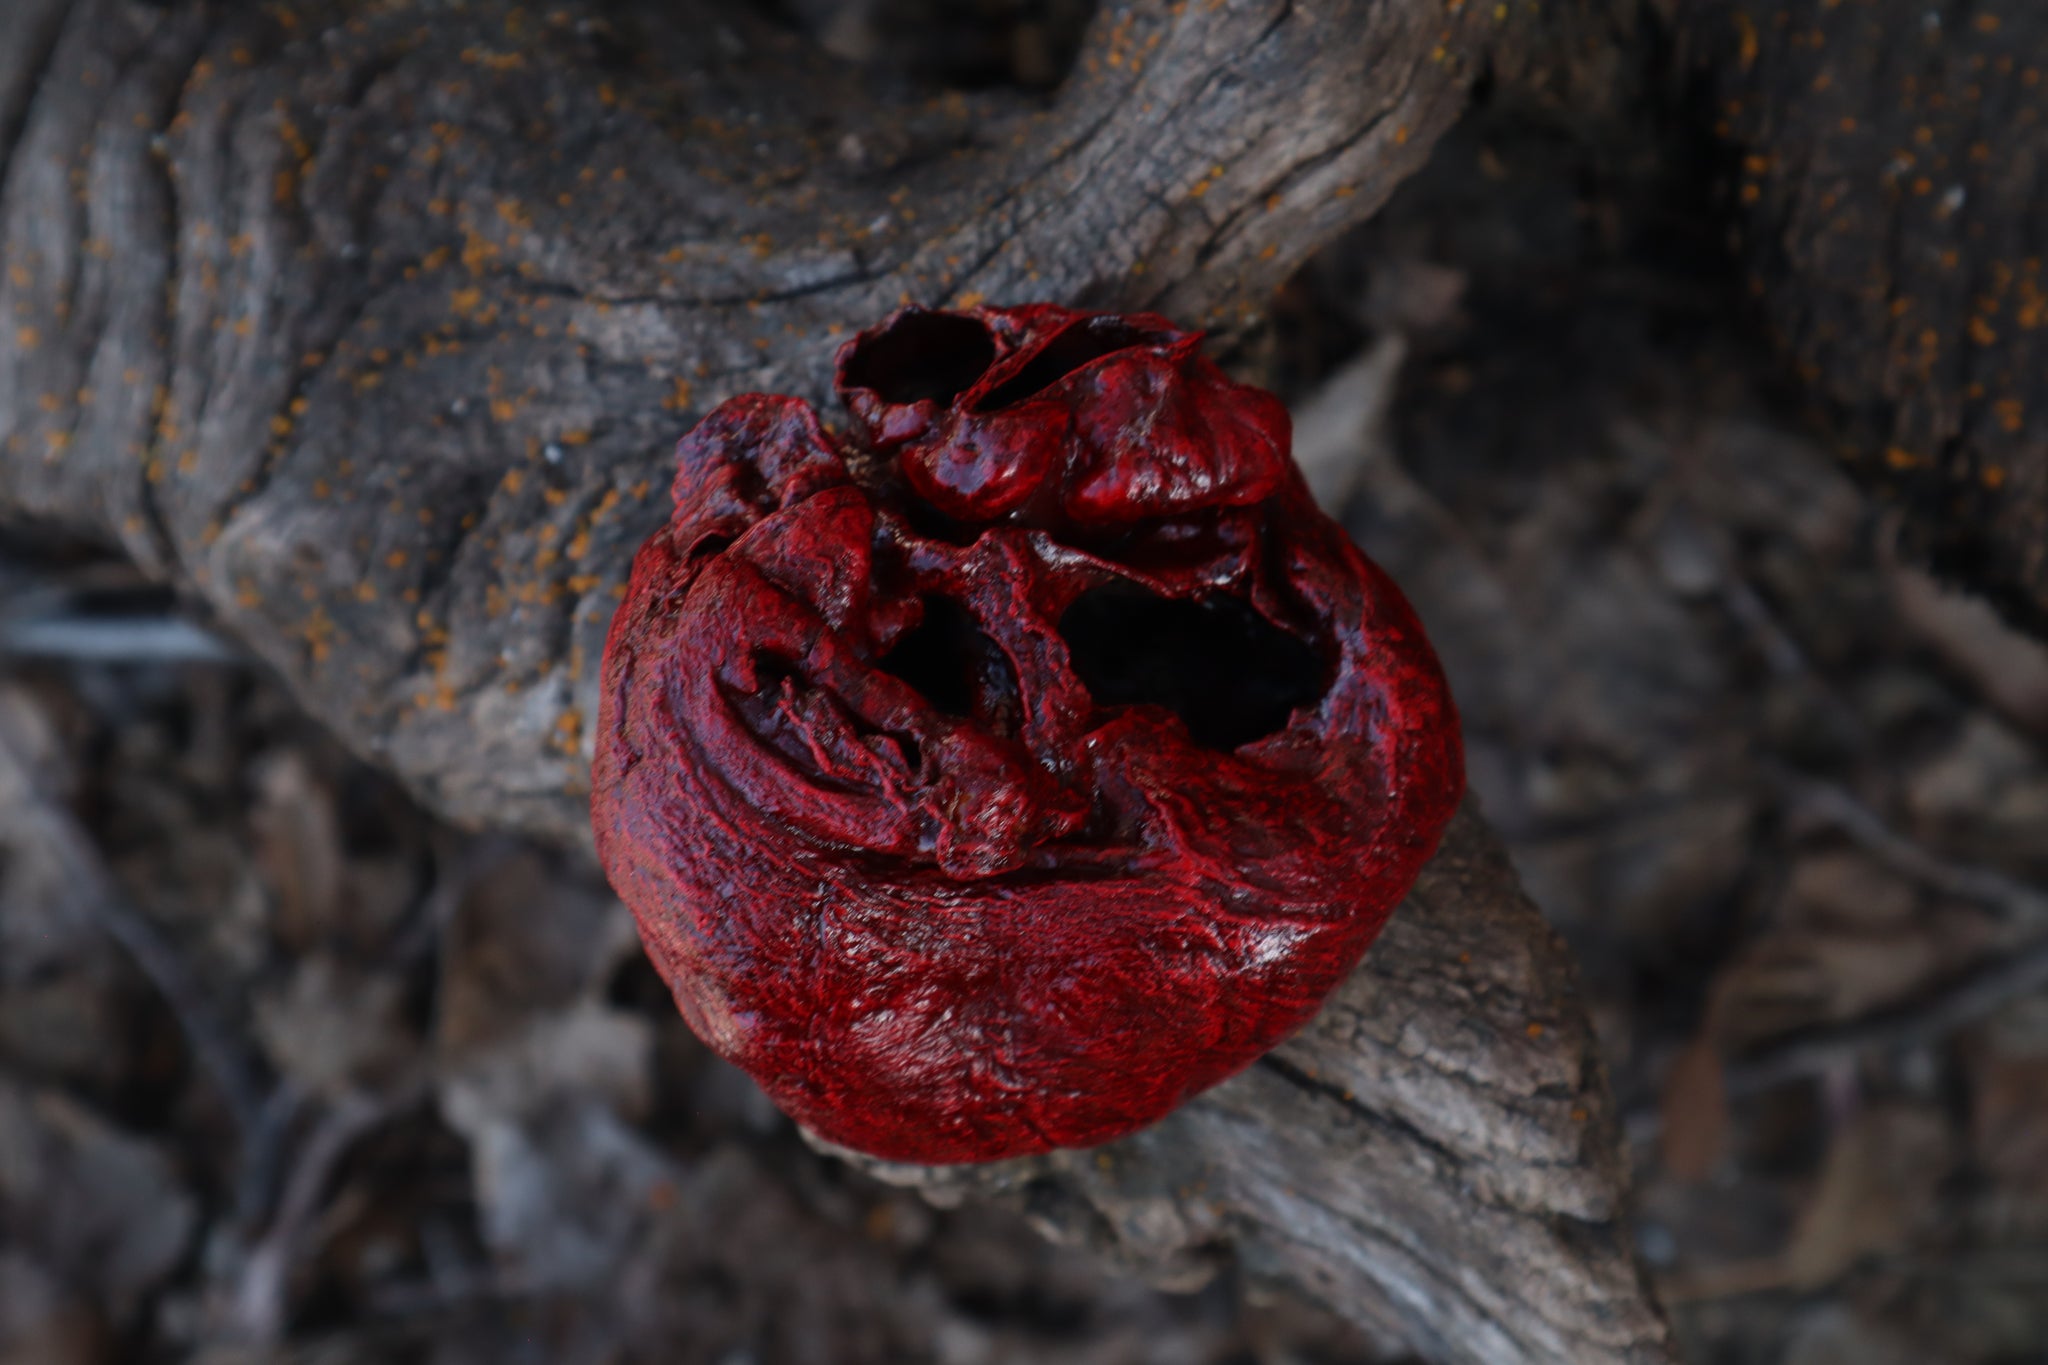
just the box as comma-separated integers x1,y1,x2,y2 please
0,0,1522,837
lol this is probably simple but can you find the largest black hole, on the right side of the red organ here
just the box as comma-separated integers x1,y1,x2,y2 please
1059,583,1329,749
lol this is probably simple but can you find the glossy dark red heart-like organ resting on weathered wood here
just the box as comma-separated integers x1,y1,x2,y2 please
592,305,1464,1162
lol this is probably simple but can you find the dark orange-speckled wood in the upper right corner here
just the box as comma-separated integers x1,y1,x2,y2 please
1679,0,2048,636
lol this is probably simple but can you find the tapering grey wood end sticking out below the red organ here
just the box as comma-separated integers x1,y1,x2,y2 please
831,802,1675,1365
